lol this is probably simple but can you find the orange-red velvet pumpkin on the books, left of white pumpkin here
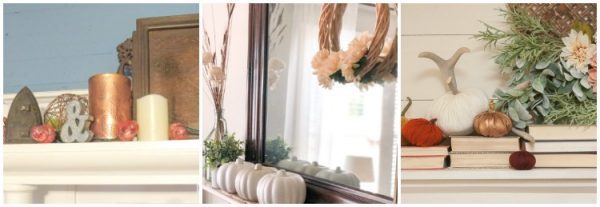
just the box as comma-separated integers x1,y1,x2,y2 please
402,118,444,147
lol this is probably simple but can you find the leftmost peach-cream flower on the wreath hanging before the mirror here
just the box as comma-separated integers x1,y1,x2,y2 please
311,50,341,88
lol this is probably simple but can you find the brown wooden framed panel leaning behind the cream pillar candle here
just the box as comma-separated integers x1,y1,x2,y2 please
132,14,200,128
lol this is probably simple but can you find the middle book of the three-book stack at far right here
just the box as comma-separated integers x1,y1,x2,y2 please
525,141,596,152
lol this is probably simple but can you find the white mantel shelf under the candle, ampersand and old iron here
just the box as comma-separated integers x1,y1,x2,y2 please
3,140,201,185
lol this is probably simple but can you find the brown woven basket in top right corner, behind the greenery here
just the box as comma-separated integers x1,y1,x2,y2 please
508,4,596,37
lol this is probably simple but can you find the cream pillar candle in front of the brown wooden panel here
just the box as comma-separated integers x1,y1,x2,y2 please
136,94,169,141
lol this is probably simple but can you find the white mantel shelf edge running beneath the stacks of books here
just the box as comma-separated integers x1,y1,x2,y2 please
401,168,596,180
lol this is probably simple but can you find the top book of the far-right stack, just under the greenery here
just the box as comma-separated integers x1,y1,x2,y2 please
529,125,596,141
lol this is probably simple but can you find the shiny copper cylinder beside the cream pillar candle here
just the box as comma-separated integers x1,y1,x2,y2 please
88,73,131,141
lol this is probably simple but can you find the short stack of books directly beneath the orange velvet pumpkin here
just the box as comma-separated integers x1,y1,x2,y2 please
400,146,448,170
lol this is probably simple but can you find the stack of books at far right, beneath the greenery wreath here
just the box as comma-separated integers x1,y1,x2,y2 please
524,125,596,168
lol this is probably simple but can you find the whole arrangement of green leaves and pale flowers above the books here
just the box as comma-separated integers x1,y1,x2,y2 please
476,7,596,129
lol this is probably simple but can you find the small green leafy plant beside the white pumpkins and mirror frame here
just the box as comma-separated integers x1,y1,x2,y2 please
202,134,244,168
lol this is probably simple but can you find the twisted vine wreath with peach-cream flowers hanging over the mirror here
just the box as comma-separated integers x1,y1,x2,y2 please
311,3,398,89
